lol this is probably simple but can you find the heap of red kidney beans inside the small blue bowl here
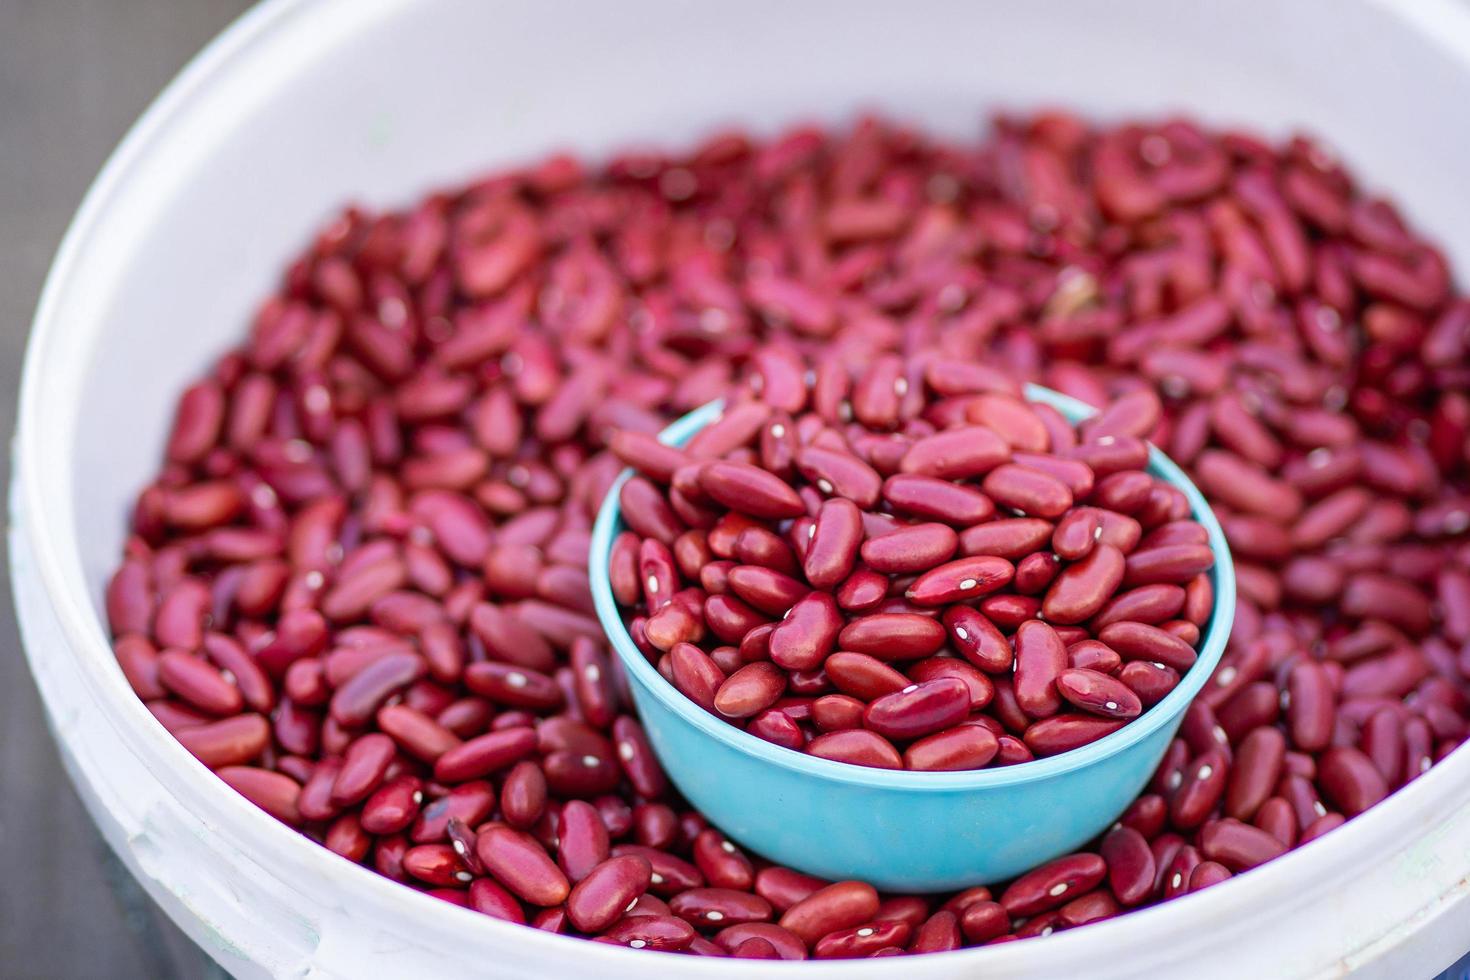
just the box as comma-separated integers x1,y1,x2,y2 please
609,371,1214,770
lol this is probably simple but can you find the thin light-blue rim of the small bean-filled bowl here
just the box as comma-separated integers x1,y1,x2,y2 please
588,383,1235,792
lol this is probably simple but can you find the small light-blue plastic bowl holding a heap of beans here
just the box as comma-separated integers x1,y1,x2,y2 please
589,385,1235,892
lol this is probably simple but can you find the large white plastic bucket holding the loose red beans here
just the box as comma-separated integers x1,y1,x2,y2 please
10,0,1470,980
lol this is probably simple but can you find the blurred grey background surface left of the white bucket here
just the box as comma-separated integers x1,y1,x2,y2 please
0,0,248,980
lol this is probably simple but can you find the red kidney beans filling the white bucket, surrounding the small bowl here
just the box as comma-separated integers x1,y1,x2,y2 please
106,115,1470,958
